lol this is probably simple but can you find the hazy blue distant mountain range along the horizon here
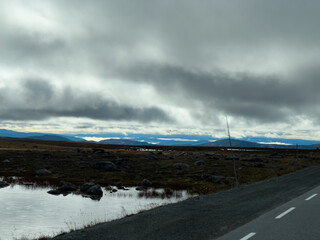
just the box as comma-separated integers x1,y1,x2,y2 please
0,129,320,149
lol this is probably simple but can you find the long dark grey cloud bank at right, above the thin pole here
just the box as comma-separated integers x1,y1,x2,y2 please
123,65,320,122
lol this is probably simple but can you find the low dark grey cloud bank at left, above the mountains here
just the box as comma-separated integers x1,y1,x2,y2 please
0,80,171,122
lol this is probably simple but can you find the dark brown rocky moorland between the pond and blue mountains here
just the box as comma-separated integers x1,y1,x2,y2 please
0,138,320,194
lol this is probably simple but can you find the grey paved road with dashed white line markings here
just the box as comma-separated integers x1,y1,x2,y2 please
218,186,320,240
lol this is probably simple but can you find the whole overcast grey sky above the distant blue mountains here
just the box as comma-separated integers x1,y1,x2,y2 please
0,0,320,140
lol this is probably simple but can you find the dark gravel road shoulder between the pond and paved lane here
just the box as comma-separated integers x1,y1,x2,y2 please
54,166,320,240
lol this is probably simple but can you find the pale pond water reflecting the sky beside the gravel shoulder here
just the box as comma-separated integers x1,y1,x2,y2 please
0,185,189,240
